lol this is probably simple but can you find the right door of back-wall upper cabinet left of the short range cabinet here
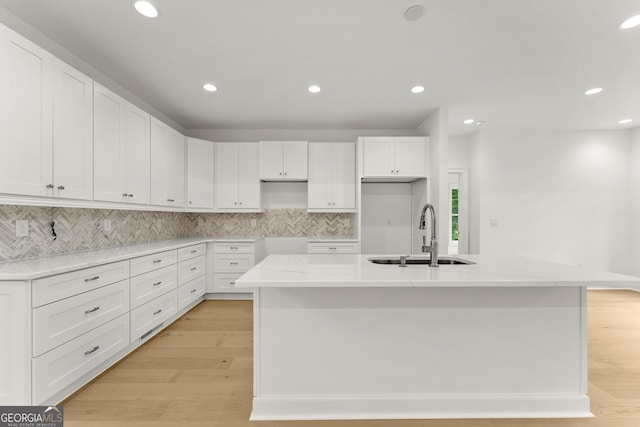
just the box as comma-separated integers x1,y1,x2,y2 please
238,142,260,209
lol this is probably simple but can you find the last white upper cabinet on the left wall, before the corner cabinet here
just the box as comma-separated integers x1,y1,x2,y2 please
151,117,185,207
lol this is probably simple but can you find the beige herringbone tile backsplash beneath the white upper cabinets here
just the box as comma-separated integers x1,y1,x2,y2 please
0,205,355,262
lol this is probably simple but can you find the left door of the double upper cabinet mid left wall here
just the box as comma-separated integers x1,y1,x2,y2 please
93,83,127,202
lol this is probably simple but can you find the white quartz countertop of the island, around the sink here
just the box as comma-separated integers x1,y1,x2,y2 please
236,254,640,288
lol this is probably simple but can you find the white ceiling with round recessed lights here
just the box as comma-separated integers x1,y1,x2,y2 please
0,0,640,134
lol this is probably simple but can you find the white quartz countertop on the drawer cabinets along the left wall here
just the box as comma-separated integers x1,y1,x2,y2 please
0,238,259,280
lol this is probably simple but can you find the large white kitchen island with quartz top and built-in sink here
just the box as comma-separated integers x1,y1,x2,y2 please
236,255,640,420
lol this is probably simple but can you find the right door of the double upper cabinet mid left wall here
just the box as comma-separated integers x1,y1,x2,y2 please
123,103,151,205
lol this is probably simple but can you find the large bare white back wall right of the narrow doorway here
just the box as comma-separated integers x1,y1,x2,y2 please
470,131,631,273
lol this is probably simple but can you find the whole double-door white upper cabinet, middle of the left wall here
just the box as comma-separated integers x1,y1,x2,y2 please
94,83,150,204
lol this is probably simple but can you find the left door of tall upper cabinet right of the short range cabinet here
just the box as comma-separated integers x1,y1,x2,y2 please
307,142,333,209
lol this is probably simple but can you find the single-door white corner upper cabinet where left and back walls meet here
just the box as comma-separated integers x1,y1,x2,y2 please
187,138,215,209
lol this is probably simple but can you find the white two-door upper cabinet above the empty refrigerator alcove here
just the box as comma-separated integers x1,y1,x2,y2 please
363,136,427,180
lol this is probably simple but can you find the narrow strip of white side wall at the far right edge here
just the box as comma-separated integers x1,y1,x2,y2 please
629,127,640,276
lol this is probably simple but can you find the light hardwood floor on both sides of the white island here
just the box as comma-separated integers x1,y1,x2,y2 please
63,290,640,427
